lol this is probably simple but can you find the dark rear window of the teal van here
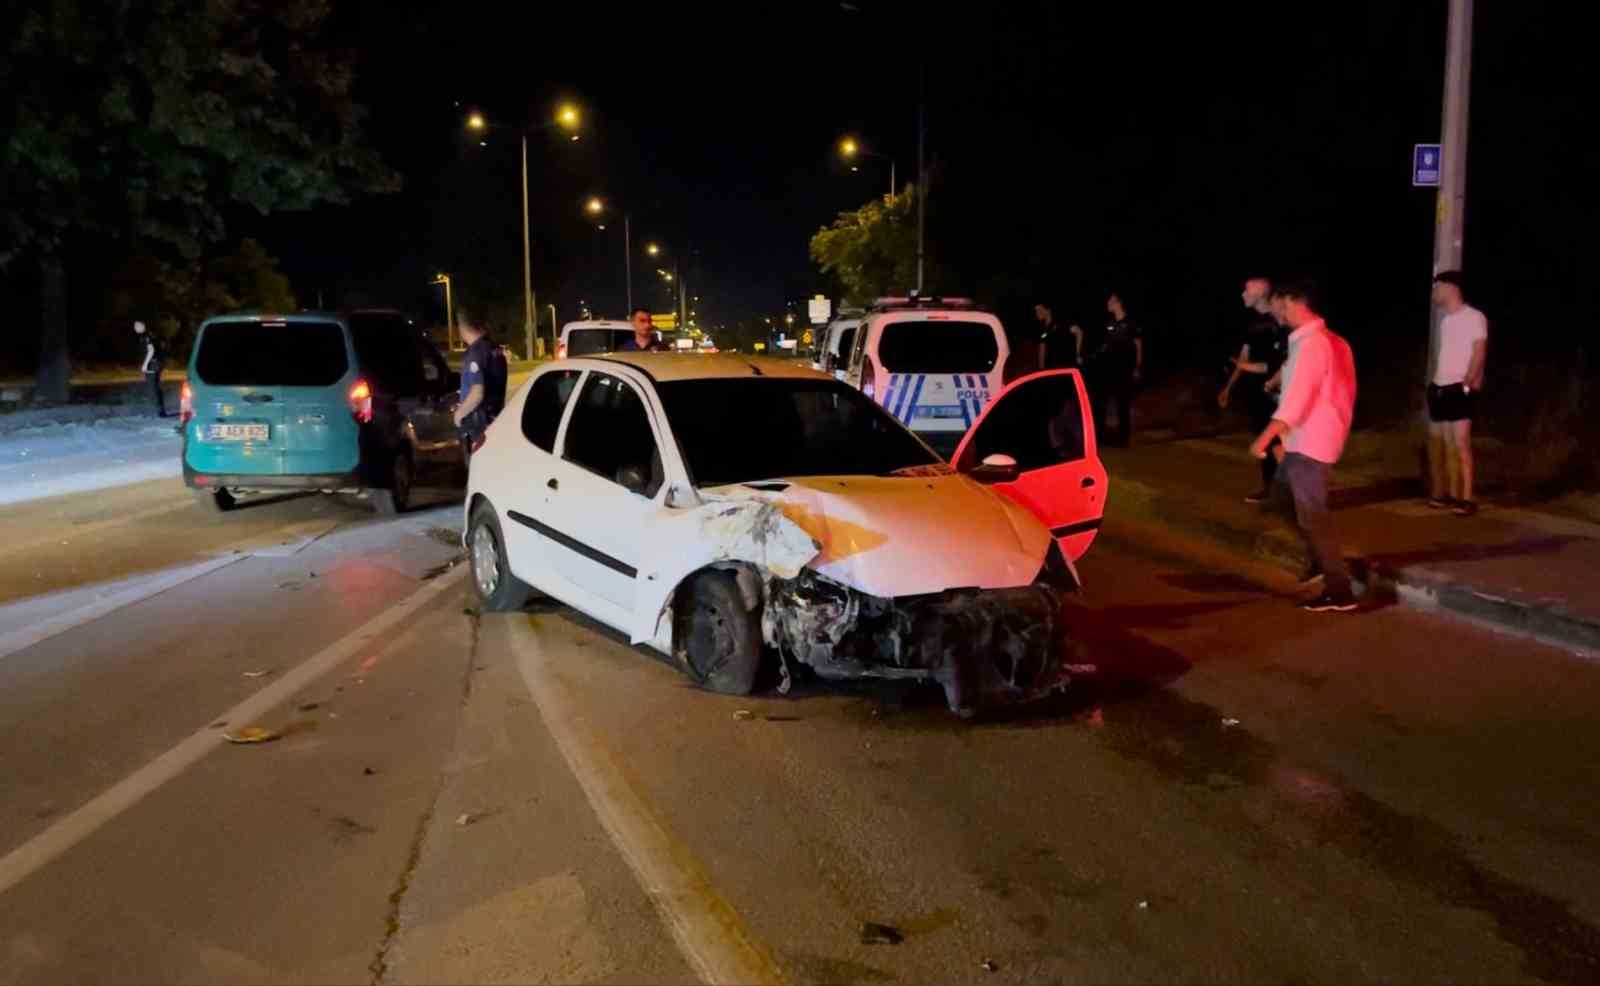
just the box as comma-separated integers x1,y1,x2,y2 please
195,319,350,387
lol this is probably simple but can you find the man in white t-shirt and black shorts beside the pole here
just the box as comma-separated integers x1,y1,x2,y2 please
1427,271,1490,517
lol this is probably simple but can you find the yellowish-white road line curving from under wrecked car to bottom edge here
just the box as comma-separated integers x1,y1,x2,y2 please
510,616,784,986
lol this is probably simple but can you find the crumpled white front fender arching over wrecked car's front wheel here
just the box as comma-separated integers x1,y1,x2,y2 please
629,495,821,653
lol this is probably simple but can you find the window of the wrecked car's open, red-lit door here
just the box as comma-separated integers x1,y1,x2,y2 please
955,375,1085,472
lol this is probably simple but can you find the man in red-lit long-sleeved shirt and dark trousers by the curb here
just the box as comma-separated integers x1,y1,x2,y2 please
1250,283,1357,613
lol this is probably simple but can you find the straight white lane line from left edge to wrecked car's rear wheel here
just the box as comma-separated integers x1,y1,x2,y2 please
0,565,466,893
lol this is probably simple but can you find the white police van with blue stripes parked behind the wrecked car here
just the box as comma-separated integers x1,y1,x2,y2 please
845,296,1011,455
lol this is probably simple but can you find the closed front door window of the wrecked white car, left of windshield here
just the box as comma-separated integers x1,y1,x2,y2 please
562,373,666,498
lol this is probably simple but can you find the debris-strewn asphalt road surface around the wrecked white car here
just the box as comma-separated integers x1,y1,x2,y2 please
0,479,1600,983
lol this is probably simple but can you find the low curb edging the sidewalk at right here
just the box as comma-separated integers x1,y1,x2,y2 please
1112,475,1600,653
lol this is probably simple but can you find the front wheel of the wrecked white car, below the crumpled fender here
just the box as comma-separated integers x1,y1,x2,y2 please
674,571,762,695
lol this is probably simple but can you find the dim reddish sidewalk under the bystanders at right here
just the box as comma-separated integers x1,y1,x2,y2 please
1102,434,1600,651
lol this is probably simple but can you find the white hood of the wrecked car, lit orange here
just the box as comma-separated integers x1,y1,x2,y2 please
707,475,1050,597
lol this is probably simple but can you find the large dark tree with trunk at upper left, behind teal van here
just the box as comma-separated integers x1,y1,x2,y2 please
0,0,398,400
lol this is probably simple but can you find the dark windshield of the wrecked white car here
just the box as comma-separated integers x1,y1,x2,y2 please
656,378,941,487
